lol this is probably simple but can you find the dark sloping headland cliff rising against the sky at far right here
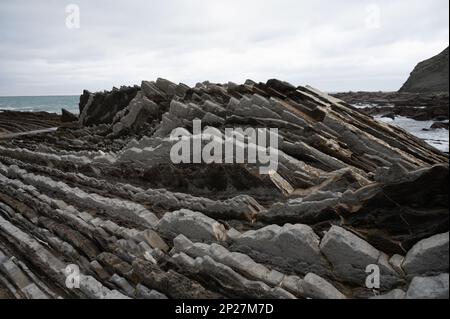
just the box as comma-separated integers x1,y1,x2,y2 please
400,48,449,92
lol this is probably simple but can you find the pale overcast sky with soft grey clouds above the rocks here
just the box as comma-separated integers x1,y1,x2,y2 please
0,0,449,95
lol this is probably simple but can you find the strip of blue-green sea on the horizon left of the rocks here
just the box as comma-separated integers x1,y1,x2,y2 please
0,95,80,114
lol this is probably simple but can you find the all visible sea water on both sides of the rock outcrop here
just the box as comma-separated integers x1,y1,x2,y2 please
0,95,449,153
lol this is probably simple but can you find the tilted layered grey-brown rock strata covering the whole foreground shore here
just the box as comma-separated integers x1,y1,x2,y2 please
0,79,449,299
